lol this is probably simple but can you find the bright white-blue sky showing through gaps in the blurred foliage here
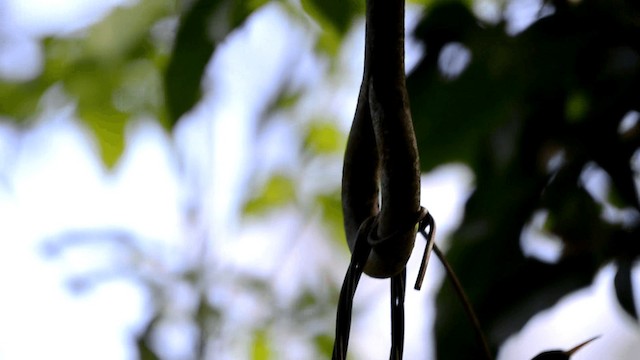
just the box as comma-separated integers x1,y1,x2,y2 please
0,0,640,360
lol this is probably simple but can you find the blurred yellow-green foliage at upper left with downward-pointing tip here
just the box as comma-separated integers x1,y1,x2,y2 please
0,0,173,168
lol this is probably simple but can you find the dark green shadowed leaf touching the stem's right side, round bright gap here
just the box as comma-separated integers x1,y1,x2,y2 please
407,2,522,171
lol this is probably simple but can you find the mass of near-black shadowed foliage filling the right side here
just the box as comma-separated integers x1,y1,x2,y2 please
408,0,640,359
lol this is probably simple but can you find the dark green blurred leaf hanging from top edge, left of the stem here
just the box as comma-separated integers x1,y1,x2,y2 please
165,0,268,127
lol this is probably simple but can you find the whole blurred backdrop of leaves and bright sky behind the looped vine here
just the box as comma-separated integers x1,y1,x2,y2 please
0,0,640,360
